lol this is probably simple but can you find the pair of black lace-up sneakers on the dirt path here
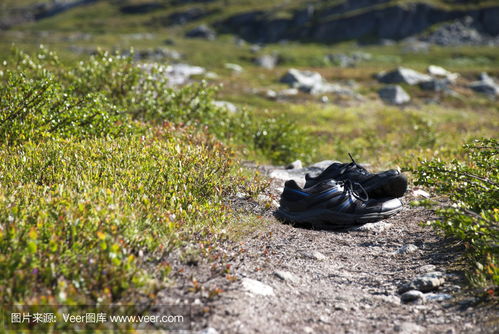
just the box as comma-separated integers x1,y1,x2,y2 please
275,156,407,227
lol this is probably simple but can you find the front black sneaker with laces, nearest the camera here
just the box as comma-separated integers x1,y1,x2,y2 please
275,180,402,227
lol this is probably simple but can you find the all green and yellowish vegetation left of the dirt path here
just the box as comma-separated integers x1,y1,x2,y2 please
0,50,285,304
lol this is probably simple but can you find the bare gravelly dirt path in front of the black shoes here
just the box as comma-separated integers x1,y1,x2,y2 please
209,209,498,334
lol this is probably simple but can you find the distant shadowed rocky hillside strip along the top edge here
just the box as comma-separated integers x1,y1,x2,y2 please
0,0,499,43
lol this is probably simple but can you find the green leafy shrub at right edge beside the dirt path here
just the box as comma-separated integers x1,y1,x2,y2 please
415,139,499,287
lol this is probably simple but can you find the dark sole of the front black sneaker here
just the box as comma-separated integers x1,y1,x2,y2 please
274,207,402,227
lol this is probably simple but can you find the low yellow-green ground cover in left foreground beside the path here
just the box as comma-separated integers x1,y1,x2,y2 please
0,126,261,304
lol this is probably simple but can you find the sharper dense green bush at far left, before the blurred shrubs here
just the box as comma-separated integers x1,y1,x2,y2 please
0,49,122,143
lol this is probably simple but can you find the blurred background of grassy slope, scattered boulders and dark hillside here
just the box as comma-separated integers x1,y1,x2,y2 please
0,0,499,165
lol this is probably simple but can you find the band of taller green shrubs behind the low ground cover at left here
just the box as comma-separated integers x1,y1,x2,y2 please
0,47,310,163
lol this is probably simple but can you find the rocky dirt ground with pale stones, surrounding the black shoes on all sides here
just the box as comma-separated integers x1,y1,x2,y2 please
160,164,499,334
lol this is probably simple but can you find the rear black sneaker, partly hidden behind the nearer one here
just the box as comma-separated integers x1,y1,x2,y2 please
305,154,407,198
